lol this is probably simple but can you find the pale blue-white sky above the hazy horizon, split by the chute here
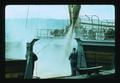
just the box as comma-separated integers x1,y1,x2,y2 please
5,5,115,19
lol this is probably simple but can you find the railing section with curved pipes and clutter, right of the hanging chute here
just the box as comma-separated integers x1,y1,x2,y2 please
80,15,115,40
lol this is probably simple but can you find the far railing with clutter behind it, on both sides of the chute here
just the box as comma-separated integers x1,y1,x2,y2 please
30,15,115,40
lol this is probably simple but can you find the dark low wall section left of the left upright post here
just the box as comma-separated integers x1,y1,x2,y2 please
5,58,27,79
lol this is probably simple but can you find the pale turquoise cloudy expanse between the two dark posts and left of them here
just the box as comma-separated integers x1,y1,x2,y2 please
5,34,77,78
